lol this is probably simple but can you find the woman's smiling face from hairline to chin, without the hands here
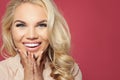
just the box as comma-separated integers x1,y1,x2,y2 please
11,3,49,54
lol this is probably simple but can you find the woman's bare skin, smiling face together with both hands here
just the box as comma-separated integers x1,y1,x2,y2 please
11,3,49,80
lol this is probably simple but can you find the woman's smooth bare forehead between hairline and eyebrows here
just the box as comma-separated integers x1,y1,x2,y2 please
14,3,47,19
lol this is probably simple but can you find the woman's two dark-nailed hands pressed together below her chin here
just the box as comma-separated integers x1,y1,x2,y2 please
19,50,44,80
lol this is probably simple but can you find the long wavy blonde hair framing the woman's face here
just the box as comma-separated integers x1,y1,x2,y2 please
2,0,74,80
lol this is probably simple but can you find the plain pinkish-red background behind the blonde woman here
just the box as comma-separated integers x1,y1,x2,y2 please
0,0,120,80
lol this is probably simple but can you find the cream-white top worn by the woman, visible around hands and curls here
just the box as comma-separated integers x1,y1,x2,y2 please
0,55,82,80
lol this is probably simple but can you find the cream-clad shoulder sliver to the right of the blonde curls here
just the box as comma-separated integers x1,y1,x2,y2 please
72,63,82,80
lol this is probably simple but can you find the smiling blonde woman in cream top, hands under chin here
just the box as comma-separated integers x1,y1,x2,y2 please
0,0,81,80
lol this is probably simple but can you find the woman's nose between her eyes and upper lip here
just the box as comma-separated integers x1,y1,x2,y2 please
27,28,38,40
